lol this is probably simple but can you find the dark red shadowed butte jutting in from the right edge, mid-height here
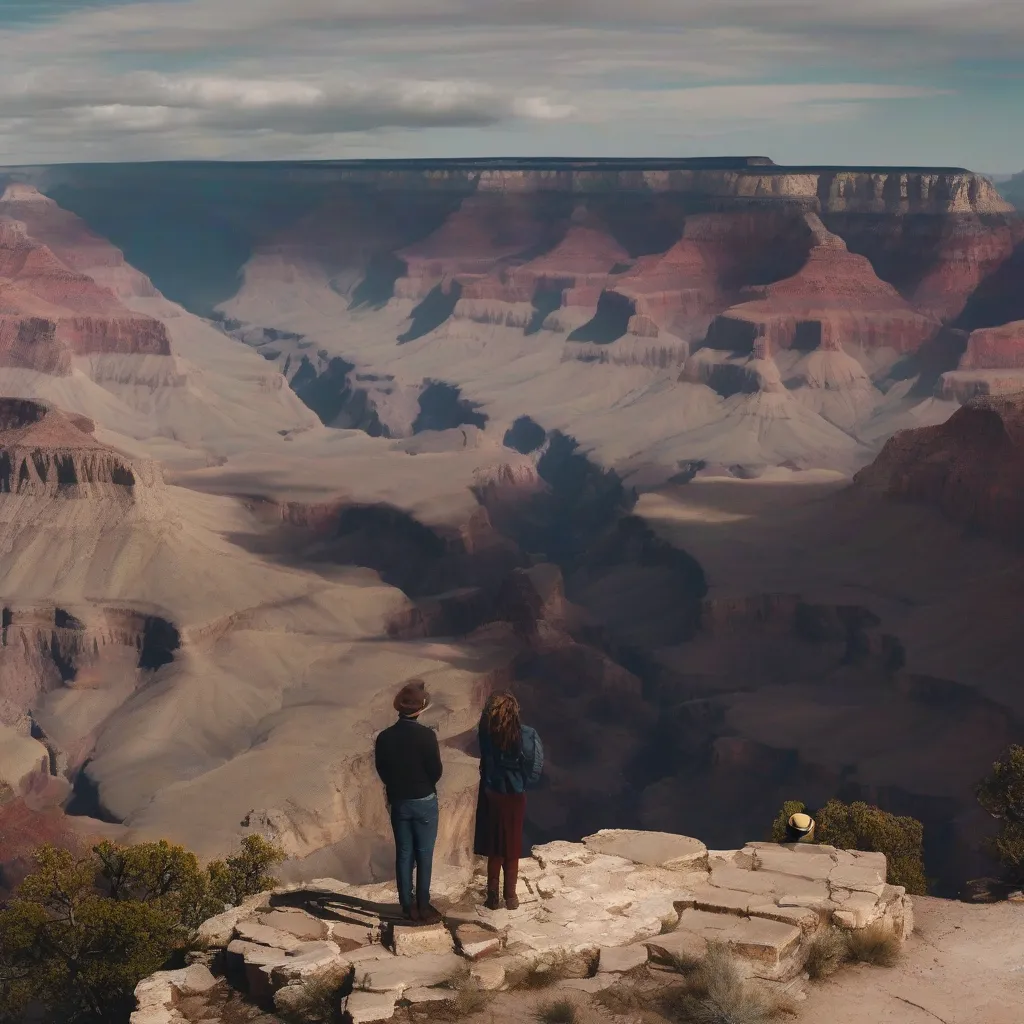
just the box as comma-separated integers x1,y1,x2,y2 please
854,394,1024,544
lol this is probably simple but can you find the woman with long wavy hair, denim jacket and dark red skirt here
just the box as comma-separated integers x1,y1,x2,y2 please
475,692,544,910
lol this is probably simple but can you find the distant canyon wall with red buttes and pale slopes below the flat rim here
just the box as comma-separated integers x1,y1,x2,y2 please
46,158,999,484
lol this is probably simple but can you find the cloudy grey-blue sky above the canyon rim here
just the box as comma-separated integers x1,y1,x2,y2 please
0,0,1024,173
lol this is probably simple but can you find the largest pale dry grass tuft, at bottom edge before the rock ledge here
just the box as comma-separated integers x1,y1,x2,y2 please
660,943,794,1024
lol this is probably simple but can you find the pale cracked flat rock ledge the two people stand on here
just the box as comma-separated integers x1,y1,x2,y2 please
131,829,913,1024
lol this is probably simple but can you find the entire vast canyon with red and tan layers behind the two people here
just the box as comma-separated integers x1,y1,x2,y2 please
0,158,1024,895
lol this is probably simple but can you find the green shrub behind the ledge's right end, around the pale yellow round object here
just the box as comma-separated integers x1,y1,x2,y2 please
771,800,928,896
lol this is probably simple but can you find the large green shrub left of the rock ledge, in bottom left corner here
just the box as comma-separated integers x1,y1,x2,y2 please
0,837,284,1024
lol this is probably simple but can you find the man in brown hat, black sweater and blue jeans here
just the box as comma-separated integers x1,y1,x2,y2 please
374,679,441,923
